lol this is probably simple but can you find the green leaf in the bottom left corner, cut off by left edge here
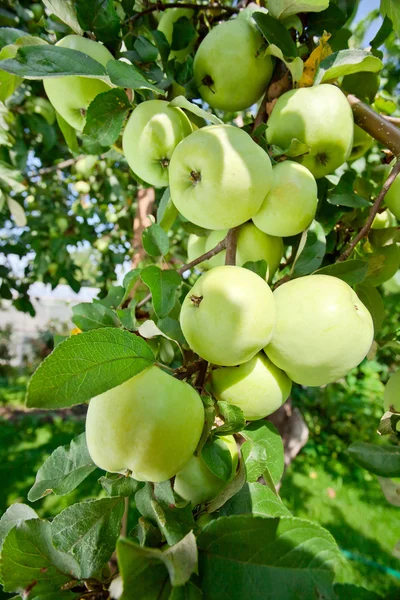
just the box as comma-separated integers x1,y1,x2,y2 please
1,518,80,597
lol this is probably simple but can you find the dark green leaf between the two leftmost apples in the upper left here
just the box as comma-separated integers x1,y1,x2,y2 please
83,89,131,146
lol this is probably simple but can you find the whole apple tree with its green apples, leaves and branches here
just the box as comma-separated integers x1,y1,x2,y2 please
0,0,400,600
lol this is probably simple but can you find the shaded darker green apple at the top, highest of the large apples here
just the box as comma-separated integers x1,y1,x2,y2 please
193,18,274,111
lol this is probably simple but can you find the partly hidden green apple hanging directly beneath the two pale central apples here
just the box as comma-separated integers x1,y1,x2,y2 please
211,352,292,421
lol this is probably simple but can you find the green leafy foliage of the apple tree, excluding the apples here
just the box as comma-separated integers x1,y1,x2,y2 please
0,0,400,600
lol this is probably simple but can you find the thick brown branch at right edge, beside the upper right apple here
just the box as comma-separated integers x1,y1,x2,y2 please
347,94,400,157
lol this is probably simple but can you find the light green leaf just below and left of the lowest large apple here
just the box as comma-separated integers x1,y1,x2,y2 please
28,433,97,502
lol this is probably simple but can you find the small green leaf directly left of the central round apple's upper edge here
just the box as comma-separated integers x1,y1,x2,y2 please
140,265,182,318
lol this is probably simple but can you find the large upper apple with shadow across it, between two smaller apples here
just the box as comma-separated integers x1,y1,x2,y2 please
169,125,272,229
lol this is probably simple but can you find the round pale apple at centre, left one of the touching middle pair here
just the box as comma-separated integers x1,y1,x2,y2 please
180,266,275,366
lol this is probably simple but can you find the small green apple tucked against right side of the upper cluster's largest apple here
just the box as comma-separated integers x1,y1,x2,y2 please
253,160,318,237
